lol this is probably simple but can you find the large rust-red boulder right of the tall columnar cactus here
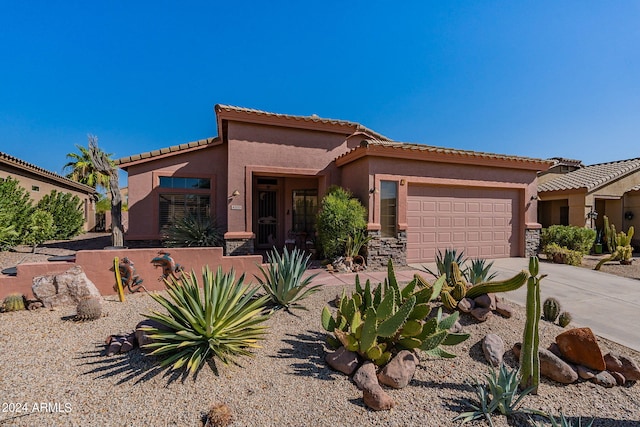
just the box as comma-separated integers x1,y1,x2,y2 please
556,328,606,371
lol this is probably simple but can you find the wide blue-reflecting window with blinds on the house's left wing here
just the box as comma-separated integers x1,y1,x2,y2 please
158,176,211,231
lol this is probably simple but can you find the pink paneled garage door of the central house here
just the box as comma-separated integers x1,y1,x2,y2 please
407,185,520,262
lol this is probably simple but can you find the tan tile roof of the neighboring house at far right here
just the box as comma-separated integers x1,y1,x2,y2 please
538,158,640,192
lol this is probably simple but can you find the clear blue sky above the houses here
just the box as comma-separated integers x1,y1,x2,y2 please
0,0,640,183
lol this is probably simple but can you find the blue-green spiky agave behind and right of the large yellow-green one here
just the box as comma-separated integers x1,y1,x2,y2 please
255,248,321,311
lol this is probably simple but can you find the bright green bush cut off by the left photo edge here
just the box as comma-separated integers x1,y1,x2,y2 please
0,177,33,249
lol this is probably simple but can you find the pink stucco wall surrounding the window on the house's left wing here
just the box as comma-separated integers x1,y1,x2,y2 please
125,145,230,240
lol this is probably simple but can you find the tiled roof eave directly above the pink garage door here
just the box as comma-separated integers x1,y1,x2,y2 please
336,139,553,170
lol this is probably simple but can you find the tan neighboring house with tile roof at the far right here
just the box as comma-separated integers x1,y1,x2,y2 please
538,158,640,242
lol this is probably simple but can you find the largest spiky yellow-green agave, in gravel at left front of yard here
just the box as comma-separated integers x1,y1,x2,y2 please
144,266,269,373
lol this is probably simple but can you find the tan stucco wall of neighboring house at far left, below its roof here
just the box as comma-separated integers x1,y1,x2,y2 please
0,164,96,231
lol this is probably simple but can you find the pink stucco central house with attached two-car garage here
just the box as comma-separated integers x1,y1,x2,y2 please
117,105,552,265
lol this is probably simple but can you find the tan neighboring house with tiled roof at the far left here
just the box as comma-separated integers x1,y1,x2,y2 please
0,152,97,231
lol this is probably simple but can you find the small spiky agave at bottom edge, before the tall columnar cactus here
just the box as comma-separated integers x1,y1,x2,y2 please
453,364,548,427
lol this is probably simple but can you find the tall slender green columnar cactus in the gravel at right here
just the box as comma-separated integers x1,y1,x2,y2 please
520,256,546,394
